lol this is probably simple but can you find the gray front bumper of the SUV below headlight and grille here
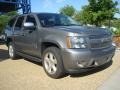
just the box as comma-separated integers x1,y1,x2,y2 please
62,46,115,73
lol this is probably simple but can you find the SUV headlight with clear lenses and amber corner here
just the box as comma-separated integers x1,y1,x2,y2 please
67,36,87,48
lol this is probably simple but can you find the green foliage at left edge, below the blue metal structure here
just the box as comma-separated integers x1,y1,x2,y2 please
0,11,18,33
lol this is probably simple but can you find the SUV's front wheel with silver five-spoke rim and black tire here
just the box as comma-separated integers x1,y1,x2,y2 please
42,47,65,79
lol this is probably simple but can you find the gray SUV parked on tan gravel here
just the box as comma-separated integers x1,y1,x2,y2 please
5,13,115,78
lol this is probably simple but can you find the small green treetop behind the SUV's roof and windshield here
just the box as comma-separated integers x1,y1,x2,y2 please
59,5,75,17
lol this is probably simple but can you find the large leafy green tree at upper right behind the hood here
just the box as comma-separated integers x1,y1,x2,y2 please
75,0,118,26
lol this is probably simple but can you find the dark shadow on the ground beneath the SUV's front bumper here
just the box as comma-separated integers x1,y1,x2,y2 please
70,60,113,78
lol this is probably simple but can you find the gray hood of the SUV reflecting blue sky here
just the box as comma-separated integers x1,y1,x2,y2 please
52,26,111,35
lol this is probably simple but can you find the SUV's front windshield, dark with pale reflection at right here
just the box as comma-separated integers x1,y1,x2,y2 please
38,14,79,27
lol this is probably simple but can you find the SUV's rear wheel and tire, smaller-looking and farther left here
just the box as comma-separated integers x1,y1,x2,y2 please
8,42,17,60
